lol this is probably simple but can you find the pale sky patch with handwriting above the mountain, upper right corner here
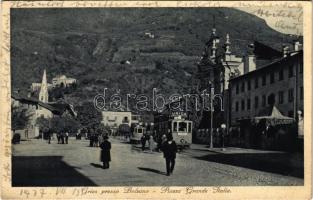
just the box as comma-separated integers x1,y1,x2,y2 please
237,7,303,35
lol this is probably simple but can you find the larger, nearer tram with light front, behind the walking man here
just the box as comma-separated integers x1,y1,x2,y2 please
154,113,193,148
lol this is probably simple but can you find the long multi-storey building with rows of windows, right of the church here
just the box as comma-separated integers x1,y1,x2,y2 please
229,48,304,127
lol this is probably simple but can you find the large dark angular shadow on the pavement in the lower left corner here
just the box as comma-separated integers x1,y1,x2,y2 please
12,156,96,187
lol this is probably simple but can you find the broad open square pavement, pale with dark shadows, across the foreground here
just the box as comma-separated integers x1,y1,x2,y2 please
12,138,304,186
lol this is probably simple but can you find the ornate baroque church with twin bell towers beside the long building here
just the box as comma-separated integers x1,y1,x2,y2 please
197,27,244,131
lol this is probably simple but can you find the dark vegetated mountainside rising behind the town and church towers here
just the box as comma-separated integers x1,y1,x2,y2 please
11,8,298,107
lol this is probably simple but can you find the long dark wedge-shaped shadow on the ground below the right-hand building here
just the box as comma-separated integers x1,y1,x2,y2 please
195,153,304,178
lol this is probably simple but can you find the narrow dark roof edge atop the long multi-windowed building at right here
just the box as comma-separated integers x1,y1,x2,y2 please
229,50,303,81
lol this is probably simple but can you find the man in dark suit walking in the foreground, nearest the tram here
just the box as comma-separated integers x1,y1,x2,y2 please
162,134,177,176
